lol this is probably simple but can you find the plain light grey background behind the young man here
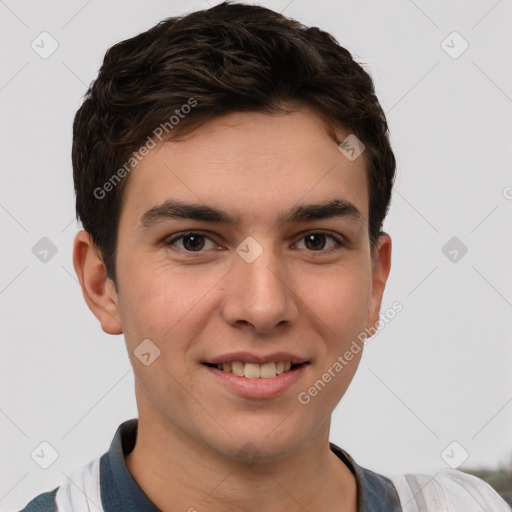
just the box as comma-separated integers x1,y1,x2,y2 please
0,0,512,510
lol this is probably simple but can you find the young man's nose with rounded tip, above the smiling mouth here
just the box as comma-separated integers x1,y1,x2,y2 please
222,241,299,334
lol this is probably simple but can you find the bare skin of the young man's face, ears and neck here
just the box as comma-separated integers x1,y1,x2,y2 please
74,108,391,512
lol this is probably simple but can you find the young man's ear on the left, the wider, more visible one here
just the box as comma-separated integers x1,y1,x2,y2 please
73,230,123,334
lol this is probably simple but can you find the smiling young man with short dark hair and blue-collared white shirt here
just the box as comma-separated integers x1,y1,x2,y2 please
18,3,509,512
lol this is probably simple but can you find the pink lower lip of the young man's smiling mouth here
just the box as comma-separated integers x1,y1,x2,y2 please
204,364,308,398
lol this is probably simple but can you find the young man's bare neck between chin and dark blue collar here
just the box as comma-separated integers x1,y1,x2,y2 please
125,414,357,512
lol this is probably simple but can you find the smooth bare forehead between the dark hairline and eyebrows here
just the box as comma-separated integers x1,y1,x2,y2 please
121,109,368,231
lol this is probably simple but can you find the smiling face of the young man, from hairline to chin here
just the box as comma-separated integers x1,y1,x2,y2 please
77,109,391,464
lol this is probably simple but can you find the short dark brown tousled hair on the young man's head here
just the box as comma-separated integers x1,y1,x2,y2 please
72,2,396,283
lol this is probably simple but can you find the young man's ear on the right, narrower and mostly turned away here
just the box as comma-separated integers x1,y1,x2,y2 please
366,233,392,332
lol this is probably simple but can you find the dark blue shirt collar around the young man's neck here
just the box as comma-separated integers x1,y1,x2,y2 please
100,418,402,512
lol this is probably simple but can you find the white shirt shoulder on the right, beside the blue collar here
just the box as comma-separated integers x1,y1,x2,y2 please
388,469,512,512
